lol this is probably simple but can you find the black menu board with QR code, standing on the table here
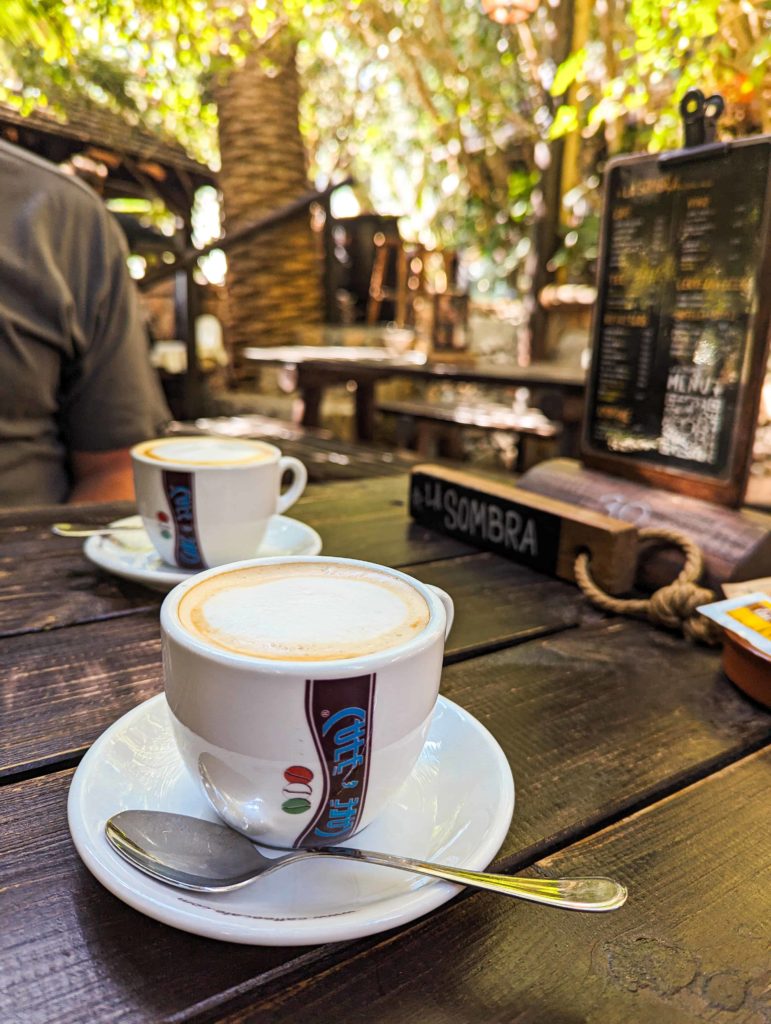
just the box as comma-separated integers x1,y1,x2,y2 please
583,136,771,504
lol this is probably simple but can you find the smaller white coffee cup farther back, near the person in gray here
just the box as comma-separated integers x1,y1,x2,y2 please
131,436,308,571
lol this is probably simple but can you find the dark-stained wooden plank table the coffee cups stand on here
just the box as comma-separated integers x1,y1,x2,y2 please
0,477,771,1024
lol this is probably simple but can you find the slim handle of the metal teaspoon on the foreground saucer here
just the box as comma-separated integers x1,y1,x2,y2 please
313,846,627,910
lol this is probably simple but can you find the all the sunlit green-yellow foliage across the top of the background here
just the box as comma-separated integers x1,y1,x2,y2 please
0,0,771,292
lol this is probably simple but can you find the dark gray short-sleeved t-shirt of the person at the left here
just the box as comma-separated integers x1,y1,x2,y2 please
0,141,170,506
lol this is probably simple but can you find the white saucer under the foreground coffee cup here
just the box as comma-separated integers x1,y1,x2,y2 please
68,694,514,946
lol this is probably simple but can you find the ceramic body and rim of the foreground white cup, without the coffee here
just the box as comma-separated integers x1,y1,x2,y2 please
161,556,454,848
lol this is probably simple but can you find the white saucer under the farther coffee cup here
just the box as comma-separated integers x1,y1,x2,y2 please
83,515,322,591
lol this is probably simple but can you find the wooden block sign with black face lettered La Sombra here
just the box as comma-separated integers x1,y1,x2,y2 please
410,465,637,594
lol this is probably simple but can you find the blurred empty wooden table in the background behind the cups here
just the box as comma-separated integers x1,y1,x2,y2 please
242,345,586,441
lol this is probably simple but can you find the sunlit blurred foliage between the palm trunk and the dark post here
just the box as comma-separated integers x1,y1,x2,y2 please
300,0,573,290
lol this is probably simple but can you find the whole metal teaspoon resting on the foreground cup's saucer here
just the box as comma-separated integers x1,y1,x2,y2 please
104,811,627,910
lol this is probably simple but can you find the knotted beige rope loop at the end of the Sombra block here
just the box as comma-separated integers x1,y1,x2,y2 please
574,527,721,644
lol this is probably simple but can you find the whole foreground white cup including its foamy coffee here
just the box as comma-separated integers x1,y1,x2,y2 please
161,556,453,848
